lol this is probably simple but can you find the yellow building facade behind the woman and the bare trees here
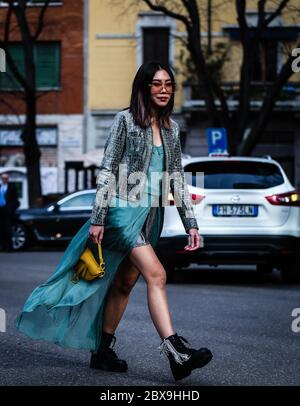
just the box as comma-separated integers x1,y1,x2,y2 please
84,0,300,187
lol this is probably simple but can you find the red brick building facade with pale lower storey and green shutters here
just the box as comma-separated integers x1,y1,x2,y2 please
0,0,84,207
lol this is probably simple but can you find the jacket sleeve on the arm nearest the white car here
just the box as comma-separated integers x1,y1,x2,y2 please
170,122,199,234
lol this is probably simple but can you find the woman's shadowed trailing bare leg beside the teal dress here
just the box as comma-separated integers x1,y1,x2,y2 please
102,257,140,334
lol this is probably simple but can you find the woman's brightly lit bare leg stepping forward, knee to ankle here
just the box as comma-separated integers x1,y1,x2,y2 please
129,244,174,339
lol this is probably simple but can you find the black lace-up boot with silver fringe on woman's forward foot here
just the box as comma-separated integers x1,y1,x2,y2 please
159,334,213,381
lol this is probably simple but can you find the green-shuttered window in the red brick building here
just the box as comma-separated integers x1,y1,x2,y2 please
0,41,61,90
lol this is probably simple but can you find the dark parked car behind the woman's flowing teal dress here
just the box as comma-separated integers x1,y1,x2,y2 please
13,189,96,251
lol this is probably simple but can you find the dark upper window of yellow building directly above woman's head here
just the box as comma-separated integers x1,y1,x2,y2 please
143,27,170,64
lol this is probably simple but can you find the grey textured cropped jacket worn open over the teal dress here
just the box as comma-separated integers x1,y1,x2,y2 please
91,109,199,233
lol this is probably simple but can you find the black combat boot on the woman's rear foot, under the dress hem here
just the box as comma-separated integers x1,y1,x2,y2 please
90,332,128,372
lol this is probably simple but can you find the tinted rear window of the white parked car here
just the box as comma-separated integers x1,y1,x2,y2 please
184,160,284,189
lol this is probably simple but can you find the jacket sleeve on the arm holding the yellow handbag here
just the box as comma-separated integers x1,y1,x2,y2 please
91,111,126,225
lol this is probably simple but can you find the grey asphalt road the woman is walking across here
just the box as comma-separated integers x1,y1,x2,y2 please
0,251,300,387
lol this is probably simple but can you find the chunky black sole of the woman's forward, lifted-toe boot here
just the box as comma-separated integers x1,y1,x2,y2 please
170,350,213,381
